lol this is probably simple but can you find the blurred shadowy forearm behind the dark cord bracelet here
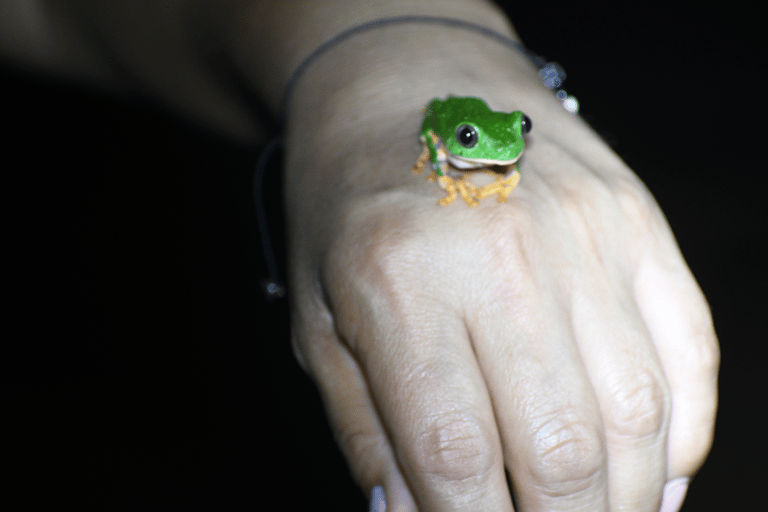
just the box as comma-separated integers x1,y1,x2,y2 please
0,0,524,141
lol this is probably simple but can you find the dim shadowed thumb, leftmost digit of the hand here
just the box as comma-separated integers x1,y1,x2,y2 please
291,287,418,512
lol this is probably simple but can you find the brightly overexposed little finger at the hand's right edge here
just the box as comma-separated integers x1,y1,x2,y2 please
635,252,720,480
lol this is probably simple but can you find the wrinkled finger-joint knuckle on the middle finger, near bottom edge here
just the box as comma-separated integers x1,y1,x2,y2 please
530,410,606,488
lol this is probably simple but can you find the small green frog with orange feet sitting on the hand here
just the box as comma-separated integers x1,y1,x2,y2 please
412,96,531,207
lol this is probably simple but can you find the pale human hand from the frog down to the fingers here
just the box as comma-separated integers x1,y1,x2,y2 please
289,82,718,511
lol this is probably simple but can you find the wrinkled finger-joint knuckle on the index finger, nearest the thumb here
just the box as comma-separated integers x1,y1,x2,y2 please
414,411,501,482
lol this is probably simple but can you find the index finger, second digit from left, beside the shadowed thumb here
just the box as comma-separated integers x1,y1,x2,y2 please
372,305,512,512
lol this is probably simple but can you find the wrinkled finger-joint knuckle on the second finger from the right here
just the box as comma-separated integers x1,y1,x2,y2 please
605,370,670,438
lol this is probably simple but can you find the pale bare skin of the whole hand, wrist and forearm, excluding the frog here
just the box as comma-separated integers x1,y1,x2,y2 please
0,0,719,512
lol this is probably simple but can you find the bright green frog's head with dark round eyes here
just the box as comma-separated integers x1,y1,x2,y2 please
445,105,531,169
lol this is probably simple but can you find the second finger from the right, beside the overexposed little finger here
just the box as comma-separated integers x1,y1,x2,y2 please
573,288,671,512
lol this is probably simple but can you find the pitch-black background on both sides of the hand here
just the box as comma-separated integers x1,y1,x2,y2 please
0,2,768,511
